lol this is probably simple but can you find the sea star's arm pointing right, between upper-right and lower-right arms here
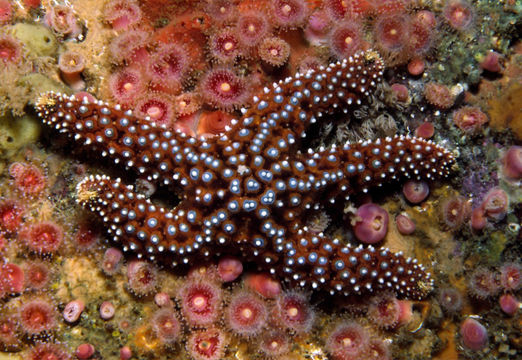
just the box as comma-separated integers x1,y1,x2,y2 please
292,135,455,203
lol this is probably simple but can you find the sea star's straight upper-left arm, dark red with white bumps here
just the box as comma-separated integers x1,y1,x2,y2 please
36,92,204,187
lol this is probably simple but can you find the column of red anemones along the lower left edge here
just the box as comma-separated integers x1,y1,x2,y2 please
0,162,97,360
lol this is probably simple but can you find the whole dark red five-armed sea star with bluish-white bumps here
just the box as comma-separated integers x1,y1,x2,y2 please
37,51,454,298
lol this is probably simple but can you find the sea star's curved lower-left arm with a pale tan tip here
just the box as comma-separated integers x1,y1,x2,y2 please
76,175,279,266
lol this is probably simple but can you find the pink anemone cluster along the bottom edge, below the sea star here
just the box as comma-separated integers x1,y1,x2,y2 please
118,257,406,360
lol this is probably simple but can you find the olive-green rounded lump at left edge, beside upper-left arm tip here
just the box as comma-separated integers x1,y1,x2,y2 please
0,115,41,157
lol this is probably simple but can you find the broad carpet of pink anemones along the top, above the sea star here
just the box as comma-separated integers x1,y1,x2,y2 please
95,0,469,142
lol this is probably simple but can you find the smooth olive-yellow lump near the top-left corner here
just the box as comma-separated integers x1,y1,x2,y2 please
12,23,58,57
